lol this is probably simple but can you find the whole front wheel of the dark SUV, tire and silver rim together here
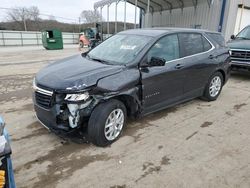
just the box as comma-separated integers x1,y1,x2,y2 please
88,99,127,147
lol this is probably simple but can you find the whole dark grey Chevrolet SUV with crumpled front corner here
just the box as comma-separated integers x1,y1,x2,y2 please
33,28,230,146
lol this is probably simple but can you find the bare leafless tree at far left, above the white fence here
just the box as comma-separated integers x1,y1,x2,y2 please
7,6,40,31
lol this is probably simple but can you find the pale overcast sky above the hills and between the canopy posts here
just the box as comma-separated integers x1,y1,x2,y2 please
0,0,139,23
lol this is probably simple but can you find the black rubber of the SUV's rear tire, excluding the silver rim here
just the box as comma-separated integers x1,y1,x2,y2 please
202,72,224,101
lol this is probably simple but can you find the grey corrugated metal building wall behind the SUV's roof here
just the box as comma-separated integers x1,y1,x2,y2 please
144,0,250,40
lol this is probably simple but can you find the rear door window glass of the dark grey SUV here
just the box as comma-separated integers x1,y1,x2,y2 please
179,33,203,57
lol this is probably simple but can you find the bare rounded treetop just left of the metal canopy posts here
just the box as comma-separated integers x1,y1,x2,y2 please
80,10,104,23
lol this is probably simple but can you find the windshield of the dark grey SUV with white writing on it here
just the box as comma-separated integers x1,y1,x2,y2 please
87,34,151,65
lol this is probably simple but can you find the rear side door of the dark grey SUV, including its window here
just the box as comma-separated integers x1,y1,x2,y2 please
178,33,215,98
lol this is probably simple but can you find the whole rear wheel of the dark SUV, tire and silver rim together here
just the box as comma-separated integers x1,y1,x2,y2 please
202,72,224,101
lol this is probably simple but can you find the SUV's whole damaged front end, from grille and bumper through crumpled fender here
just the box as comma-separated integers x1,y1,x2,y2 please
33,65,141,136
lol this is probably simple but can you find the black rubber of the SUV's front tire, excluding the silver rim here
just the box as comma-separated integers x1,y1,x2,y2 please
88,99,127,147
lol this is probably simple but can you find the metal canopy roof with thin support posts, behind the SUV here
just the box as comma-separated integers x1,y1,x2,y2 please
94,0,214,34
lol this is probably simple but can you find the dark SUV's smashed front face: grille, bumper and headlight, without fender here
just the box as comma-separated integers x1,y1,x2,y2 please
33,83,99,132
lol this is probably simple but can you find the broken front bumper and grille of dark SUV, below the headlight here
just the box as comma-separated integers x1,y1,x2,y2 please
33,87,95,132
